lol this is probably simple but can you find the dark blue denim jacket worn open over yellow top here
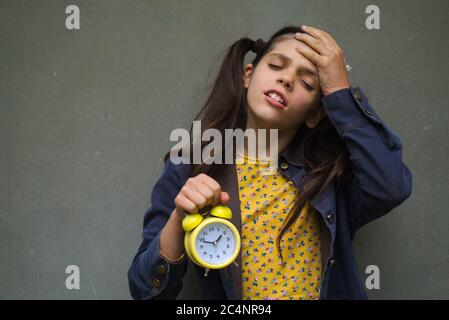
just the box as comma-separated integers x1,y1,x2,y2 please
128,87,412,300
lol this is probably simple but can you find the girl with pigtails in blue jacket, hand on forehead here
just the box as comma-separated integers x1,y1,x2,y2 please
128,26,412,300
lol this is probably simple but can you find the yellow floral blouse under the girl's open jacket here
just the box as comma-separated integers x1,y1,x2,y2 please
236,155,321,300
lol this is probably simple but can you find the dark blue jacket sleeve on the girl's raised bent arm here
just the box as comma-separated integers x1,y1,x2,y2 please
322,87,412,234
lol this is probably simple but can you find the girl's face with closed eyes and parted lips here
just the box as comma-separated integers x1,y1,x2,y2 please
243,35,324,131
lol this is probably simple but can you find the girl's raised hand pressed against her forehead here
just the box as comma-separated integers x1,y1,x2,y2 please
295,26,350,96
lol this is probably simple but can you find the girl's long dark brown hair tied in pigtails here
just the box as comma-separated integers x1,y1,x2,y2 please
164,26,351,258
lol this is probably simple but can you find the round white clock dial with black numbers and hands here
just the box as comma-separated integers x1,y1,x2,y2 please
195,222,236,264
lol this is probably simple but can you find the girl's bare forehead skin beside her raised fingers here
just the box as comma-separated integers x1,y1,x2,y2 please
264,35,318,73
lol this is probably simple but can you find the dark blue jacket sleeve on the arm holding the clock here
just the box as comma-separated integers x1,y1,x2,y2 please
128,160,187,300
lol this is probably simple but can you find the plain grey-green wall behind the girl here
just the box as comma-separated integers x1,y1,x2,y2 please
0,0,449,299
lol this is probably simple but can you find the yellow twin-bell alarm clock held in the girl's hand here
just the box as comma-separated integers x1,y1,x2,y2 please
182,205,241,276
